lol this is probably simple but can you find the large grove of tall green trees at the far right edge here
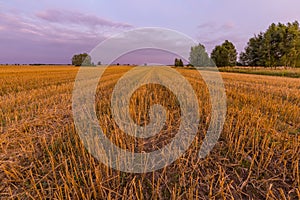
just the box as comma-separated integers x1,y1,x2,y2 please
240,21,300,67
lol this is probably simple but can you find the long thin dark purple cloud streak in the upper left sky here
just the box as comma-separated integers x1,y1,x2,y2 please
36,10,132,28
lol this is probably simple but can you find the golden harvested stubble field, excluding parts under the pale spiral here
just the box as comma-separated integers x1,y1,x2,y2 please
0,66,300,199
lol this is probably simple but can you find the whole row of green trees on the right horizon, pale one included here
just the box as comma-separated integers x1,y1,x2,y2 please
182,21,300,67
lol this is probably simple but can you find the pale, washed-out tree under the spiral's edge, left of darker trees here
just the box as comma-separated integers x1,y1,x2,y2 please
189,44,214,67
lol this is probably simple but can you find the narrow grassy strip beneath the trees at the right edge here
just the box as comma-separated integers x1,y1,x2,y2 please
219,67,300,78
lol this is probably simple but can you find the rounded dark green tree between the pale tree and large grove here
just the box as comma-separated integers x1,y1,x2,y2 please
211,40,237,67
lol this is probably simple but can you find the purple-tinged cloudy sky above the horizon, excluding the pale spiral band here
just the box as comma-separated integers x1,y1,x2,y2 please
0,0,300,64
